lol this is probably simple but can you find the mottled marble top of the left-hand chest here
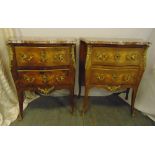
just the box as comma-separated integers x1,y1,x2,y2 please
7,37,77,44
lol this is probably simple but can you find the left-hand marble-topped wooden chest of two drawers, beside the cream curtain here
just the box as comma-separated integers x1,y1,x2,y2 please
8,39,76,118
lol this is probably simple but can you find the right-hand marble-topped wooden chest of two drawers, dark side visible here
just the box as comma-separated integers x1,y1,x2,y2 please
79,39,149,113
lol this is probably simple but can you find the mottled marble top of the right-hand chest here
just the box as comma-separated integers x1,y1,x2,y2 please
81,38,150,46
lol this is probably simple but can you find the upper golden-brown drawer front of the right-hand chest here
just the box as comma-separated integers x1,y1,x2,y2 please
91,47,144,66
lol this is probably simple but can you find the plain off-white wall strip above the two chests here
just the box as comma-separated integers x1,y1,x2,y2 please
16,28,152,40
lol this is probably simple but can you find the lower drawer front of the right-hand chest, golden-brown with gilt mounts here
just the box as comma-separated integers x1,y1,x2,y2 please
90,68,138,85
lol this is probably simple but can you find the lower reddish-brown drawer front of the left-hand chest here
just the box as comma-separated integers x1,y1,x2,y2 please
18,69,73,86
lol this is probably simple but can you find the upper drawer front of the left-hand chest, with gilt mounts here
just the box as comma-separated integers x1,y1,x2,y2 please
15,47,71,67
